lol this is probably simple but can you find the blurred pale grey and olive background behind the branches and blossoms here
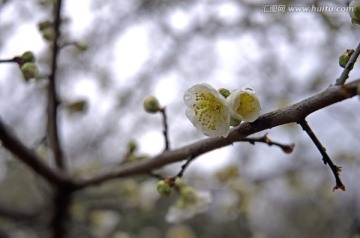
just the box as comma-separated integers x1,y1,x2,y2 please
0,0,360,238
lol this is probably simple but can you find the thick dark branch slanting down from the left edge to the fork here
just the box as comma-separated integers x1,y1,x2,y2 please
0,118,69,186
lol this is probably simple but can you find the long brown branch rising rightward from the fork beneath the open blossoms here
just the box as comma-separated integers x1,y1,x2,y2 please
71,79,360,189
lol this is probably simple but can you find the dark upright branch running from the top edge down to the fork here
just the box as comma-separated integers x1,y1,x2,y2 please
47,0,65,169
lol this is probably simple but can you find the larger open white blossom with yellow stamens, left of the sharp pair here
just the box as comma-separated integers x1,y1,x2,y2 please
184,83,231,137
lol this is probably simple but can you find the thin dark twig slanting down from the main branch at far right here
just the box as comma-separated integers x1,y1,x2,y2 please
298,119,345,191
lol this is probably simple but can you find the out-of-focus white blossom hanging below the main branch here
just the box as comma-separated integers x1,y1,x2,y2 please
165,190,211,223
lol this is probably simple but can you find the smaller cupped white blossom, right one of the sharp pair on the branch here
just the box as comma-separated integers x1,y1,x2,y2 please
226,86,261,122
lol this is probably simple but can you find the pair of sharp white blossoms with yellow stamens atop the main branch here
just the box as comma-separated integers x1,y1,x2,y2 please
184,83,261,137
